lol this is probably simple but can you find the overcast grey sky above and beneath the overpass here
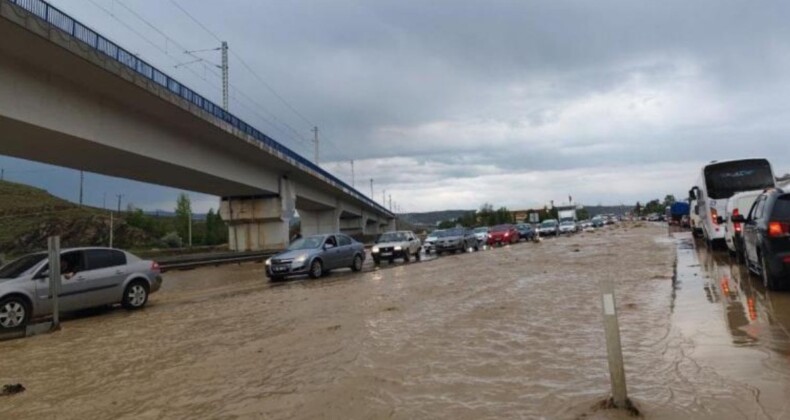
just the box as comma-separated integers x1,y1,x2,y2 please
0,0,790,211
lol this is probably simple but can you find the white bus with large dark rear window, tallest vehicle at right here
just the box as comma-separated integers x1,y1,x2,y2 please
689,159,776,246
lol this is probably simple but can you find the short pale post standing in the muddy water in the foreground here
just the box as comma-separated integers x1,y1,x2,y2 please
600,280,628,408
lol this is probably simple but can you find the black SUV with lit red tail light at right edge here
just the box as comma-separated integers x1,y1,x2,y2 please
732,188,790,290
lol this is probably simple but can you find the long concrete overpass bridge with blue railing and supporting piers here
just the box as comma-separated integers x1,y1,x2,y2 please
0,0,394,250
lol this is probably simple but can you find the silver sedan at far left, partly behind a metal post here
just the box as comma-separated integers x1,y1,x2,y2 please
0,248,162,330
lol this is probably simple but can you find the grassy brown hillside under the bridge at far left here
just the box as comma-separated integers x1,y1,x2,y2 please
0,181,155,256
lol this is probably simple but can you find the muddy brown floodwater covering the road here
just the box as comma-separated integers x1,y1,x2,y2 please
0,225,790,419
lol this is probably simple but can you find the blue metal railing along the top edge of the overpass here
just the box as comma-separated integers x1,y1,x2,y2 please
9,0,391,214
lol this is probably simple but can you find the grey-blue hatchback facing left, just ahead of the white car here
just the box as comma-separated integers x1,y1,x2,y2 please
265,233,365,281
